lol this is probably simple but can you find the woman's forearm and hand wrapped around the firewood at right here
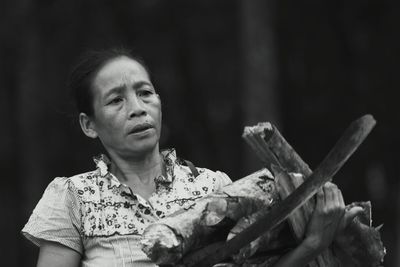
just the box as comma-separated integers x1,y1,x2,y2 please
274,182,362,267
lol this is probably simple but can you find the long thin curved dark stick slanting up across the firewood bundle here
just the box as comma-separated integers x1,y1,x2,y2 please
187,115,375,267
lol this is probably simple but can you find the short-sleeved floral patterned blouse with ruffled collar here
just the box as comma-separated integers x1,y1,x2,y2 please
22,149,231,266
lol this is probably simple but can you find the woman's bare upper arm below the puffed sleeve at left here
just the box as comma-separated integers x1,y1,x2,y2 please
37,241,81,267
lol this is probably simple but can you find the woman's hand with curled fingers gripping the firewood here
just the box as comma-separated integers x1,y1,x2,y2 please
301,182,346,254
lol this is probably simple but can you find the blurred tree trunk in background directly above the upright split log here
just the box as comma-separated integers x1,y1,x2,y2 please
239,0,280,170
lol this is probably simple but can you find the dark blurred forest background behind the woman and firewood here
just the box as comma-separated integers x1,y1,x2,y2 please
0,0,400,266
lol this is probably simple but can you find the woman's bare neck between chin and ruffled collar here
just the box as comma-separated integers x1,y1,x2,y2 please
110,147,163,185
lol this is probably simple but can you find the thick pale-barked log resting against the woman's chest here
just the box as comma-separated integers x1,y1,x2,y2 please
141,169,279,264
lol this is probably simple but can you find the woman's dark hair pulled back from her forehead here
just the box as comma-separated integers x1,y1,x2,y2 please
68,48,150,116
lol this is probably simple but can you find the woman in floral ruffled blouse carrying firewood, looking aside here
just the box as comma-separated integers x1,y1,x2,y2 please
23,50,360,266
